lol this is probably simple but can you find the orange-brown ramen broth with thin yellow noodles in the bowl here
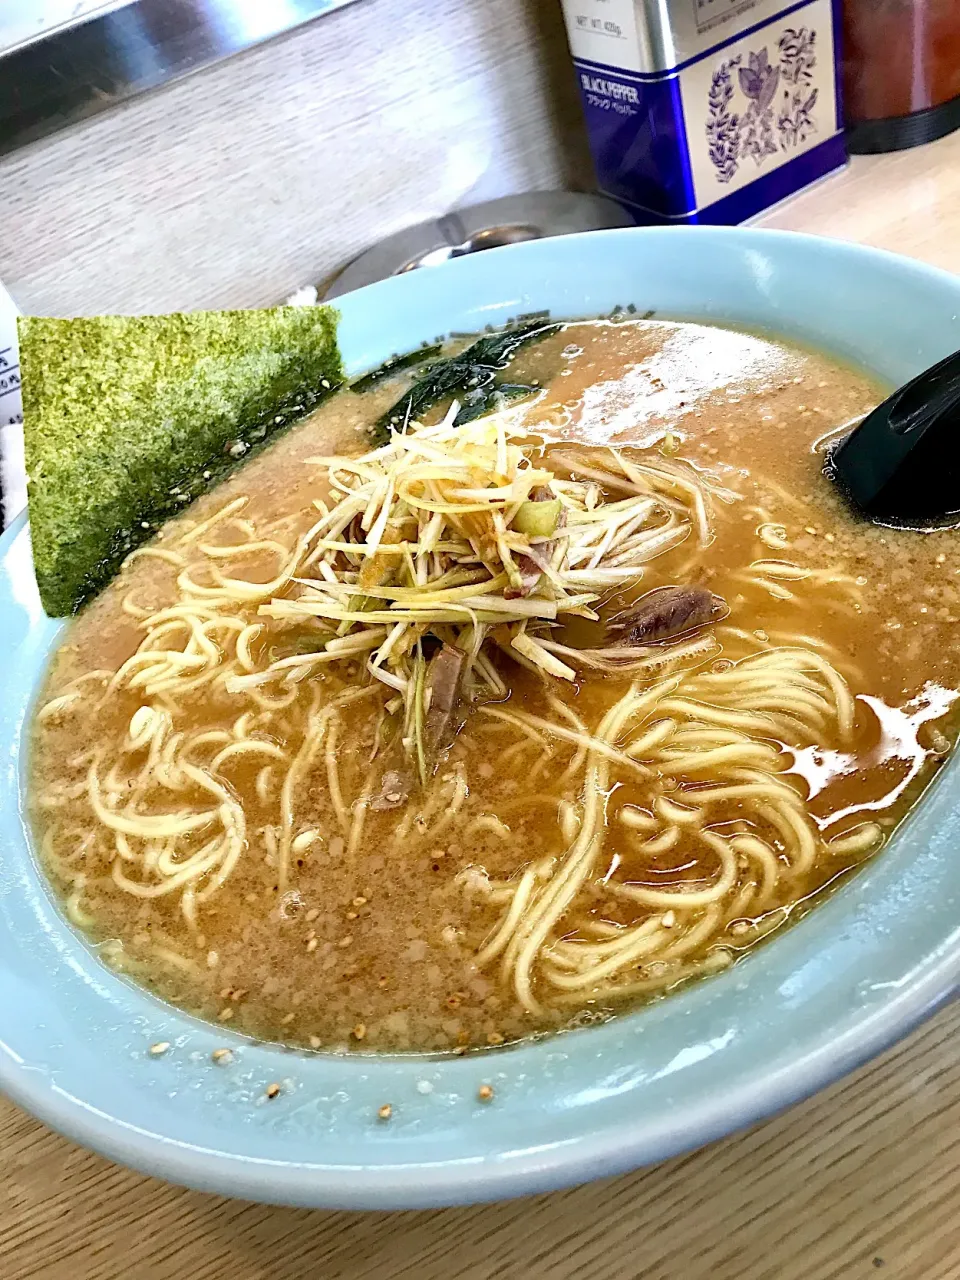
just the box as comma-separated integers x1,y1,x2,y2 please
31,320,960,1051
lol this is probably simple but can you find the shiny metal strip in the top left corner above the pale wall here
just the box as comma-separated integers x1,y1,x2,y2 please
0,0,363,155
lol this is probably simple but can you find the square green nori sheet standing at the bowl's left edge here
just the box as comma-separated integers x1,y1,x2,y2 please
19,307,343,617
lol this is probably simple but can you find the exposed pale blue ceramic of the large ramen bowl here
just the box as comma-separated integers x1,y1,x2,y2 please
0,228,960,1208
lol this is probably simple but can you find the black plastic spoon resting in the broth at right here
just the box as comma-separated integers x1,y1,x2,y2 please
824,351,960,527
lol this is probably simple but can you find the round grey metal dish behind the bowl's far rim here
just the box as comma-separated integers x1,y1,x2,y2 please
324,191,634,298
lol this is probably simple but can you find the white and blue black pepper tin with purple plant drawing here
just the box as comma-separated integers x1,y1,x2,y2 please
563,0,846,224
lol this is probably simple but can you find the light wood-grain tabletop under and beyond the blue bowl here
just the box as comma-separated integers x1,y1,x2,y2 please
0,120,960,1280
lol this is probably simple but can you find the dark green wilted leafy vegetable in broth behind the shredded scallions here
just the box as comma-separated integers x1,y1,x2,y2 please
372,320,562,444
